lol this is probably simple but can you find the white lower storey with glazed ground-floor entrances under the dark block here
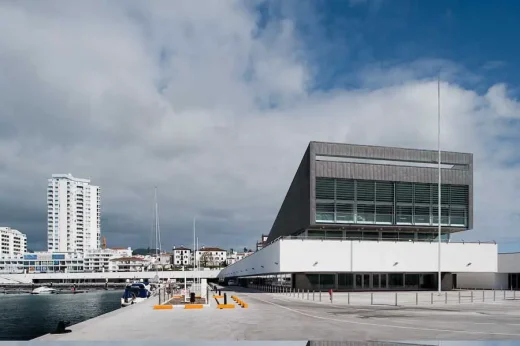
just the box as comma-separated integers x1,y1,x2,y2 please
219,239,498,289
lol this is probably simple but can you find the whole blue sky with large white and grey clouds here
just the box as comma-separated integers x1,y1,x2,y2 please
0,0,520,251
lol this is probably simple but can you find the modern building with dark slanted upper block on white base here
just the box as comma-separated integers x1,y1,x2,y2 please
220,142,497,290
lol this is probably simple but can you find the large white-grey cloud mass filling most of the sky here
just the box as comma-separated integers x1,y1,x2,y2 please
0,1,519,247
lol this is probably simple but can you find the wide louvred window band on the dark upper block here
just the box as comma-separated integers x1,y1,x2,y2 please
316,177,469,227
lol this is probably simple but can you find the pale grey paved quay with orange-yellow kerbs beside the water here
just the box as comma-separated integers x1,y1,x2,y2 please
36,287,520,341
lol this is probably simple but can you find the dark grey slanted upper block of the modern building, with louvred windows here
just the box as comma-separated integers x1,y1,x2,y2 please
268,142,473,241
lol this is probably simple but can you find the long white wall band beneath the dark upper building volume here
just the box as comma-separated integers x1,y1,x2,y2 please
219,239,497,277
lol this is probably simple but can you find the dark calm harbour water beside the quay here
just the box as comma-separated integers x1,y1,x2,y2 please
0,291,123,340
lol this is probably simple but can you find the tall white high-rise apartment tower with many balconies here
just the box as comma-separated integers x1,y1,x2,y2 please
47,173,101,252
